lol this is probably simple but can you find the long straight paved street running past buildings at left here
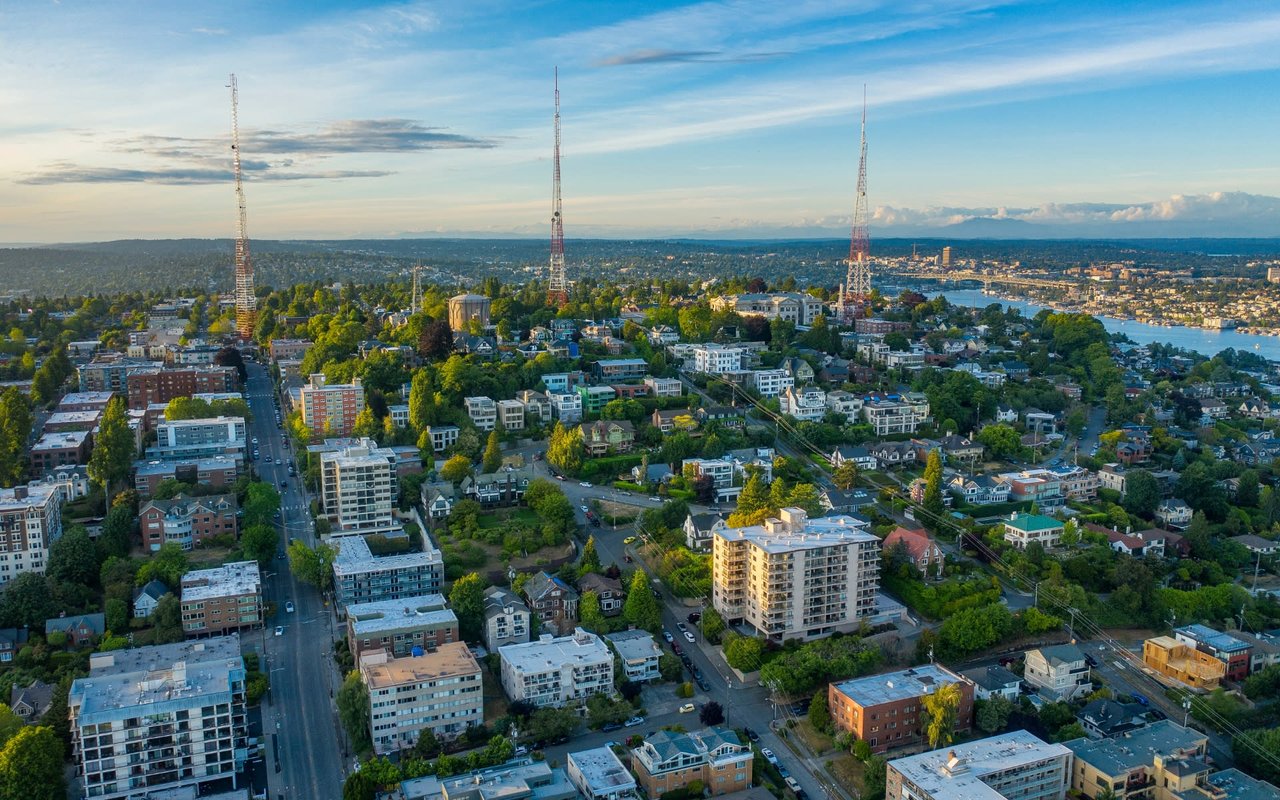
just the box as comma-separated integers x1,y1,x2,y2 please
247,364,351,800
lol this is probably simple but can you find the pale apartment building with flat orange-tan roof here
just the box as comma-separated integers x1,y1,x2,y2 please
360,641,484,755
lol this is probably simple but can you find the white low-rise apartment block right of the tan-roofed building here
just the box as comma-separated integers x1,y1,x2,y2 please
498,628,613,707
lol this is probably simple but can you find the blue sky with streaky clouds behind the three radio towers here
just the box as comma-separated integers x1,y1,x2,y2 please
0,0,1280,243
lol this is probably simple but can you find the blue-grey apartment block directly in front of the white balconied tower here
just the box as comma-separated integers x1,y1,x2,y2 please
333,536,444,608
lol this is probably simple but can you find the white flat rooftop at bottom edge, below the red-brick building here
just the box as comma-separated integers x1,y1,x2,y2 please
888,731,1071,800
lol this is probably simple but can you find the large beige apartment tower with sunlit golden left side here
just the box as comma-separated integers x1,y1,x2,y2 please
712,508,879,641
